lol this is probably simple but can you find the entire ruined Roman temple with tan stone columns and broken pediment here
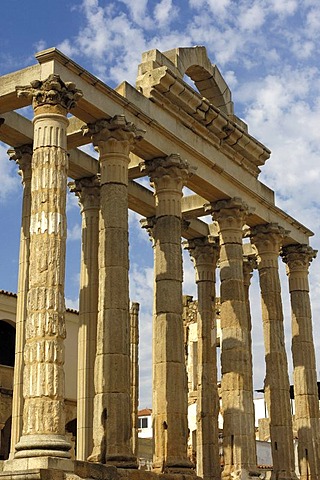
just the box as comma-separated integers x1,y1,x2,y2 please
0,47,320,480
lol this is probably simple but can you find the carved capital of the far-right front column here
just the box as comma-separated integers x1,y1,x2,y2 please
280,244,318,274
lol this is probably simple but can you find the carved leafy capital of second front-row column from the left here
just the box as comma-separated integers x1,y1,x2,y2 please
82,115,145,155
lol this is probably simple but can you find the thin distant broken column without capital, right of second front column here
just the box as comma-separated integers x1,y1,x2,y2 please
130,302,139,457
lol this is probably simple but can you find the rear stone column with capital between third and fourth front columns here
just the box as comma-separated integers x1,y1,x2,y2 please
185,237,221,480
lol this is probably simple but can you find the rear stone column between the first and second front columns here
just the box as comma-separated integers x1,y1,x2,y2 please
69,176,100,460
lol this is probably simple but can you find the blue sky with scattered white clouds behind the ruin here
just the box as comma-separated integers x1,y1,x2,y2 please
0,0,320,407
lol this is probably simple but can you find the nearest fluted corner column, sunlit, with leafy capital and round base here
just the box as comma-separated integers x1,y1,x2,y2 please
15,75,81,465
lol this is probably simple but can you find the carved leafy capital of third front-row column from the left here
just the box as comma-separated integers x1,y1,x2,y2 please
140,153,194,188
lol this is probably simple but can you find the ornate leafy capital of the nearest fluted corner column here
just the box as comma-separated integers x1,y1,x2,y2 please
16,74,83,115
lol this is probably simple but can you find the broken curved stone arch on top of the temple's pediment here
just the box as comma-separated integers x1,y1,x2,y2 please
163,46,234,115
